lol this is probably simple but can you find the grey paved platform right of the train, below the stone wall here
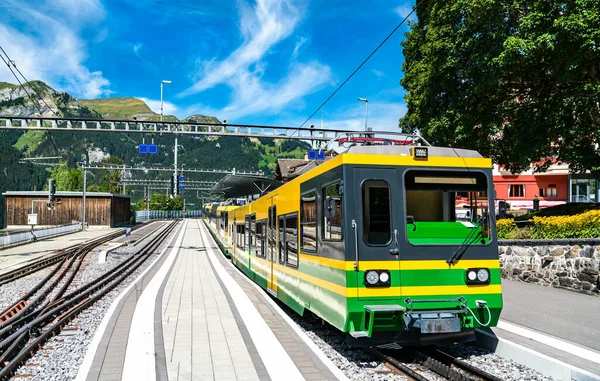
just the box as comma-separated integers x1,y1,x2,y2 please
492,279,600,380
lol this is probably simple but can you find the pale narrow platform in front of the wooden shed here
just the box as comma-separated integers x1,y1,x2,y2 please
0,228,122,273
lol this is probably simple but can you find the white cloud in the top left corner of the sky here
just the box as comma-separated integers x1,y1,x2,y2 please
0,0,110,98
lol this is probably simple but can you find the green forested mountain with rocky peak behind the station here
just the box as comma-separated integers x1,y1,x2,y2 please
0,81,310,226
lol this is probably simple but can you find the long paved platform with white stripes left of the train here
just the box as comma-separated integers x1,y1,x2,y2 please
77,219,347,381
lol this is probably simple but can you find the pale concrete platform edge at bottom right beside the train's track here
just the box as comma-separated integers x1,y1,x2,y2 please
476,329,600,381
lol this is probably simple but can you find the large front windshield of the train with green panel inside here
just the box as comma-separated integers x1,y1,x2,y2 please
404,170,490,245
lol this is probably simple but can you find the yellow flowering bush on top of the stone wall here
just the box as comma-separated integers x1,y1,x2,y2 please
496,210,600,239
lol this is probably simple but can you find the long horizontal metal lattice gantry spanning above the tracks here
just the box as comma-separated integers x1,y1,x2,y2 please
0,116,364,141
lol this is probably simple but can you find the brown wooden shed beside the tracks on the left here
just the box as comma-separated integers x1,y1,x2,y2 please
2,191,131,227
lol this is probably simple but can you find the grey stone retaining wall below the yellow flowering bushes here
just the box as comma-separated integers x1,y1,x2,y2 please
498,240,600,295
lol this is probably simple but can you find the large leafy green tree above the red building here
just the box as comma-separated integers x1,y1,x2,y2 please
400,0,600,175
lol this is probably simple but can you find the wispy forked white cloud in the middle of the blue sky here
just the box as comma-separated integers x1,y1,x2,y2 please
179,0,331,120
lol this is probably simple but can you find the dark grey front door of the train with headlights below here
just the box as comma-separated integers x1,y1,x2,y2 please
351,168,401,299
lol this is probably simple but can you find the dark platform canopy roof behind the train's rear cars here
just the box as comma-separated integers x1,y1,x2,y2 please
210,175,283,198
